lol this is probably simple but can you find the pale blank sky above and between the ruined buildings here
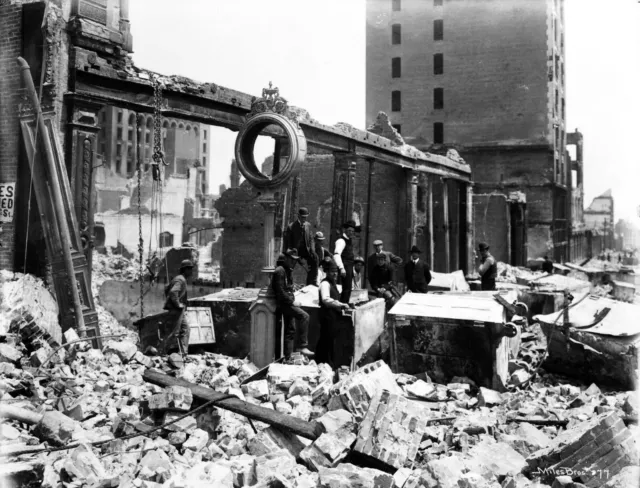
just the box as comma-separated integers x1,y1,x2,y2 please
130,0,640,222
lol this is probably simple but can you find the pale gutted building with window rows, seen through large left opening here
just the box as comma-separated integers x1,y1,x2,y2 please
95,106,217,254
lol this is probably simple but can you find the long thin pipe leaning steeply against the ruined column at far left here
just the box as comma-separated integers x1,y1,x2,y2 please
17,57,87,337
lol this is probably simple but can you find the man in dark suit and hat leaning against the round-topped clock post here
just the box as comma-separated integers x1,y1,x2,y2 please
271,249,313,357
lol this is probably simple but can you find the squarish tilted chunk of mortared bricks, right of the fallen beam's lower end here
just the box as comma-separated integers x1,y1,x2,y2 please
354,390,432,468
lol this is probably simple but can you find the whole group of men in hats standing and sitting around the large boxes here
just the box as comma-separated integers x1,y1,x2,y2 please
165,207,497,364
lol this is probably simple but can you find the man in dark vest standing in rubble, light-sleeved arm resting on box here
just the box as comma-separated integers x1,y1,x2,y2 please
315,260,349,368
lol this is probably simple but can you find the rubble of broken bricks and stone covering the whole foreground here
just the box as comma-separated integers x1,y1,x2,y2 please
0,318,639,488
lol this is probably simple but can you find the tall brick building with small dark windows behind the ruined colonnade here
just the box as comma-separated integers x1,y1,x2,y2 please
366,0,571,260
